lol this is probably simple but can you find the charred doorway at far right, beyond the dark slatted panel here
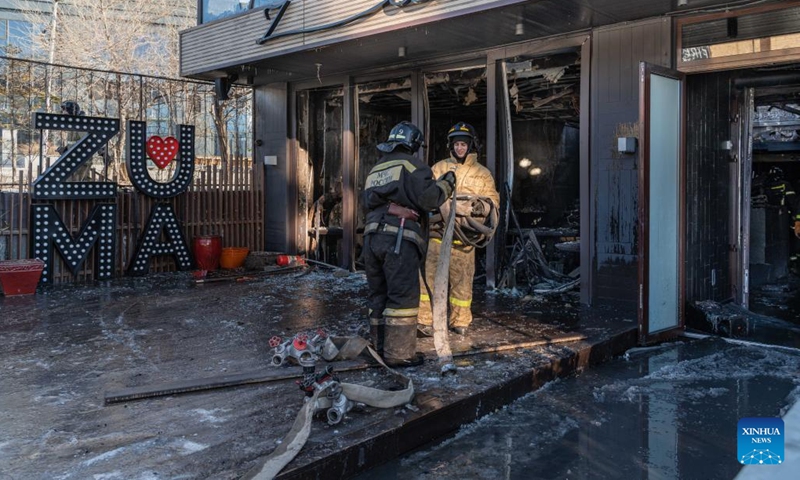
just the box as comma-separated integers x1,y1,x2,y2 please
733,64,800,321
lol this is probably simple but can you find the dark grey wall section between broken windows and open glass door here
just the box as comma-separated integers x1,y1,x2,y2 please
591,18,672,309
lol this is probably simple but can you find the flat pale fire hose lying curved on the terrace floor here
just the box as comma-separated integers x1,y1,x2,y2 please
242,337,414,480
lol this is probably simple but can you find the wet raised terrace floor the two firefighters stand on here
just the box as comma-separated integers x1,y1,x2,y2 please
0,270,635,480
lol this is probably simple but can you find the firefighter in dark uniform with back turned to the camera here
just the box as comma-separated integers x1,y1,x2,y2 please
363,122,456,367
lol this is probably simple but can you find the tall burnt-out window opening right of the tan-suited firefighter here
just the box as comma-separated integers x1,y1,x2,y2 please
498,49,581,292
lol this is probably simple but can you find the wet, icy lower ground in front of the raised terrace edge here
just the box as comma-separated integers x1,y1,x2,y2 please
357,337,800,480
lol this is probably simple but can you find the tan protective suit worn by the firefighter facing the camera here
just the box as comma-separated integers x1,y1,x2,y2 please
418,153,500,327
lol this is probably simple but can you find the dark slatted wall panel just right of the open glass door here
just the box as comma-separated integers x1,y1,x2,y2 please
685,72,732,303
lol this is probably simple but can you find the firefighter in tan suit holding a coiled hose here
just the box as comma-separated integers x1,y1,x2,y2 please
419,122,500,336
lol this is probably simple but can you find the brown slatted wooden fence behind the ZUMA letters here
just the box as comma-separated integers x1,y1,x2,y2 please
0,157,264,283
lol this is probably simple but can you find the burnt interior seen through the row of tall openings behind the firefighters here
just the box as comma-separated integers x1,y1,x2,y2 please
297,50,581,287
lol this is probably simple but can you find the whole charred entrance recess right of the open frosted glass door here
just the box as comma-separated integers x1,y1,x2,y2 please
685,64,800,326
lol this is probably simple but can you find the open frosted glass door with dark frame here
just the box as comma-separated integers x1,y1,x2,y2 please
638,62,685,344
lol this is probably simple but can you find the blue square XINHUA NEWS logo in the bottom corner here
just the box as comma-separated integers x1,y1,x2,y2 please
736,418,785,465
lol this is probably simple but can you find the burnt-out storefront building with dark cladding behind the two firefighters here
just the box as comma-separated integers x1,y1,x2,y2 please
181,0,800,341
